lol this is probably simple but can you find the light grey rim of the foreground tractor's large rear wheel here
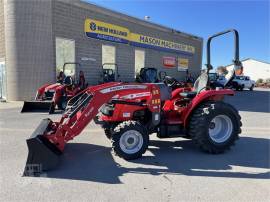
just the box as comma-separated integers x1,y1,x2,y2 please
209,115,233,143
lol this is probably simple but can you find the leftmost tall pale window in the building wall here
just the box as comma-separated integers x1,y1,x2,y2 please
55,37,75,76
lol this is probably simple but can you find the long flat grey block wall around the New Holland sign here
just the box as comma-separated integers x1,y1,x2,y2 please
53,1,202,84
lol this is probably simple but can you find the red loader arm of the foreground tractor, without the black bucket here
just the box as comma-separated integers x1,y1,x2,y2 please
45,83,159,151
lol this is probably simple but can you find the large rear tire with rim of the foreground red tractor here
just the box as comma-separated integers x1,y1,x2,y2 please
189,101,242,154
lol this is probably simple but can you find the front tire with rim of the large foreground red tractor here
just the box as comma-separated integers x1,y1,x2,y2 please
111,121,149,160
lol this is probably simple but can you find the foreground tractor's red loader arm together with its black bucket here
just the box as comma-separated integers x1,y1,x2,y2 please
24,82,160,174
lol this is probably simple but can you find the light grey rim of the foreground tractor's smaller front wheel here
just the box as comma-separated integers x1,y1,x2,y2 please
120,130,143,154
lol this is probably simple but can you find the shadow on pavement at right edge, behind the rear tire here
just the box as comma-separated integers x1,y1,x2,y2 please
225,90,270,113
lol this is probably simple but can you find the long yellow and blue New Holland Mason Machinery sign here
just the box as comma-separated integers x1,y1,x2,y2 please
84,19,195,55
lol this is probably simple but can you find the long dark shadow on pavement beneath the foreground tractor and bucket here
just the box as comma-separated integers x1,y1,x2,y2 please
41,137,270,184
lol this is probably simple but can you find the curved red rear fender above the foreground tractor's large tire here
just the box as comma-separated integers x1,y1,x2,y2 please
182,89,235,128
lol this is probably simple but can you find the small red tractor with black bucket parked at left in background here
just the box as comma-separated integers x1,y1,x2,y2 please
21,62,87,114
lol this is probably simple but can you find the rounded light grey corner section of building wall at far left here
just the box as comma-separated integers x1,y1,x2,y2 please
4,0,55,100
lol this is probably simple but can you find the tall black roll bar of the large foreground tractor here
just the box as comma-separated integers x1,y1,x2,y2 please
206,29,241,74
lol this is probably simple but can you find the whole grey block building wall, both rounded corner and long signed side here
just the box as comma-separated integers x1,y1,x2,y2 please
0,0,202,100
